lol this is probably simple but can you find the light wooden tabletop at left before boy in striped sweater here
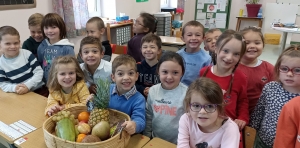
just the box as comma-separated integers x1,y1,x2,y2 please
0,90,47,144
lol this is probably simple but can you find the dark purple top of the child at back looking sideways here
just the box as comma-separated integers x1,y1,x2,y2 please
127,33,146,62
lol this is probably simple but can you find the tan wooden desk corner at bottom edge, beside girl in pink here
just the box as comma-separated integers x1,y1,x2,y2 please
143,138,177,148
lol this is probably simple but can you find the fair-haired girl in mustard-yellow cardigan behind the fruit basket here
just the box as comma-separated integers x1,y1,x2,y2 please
45,56,90,116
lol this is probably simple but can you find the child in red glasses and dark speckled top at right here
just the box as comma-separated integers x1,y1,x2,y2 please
250,45,300,148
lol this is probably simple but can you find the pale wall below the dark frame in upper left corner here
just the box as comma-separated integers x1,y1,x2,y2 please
0,0,53,43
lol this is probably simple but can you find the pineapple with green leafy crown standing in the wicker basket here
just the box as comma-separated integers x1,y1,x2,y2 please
88,79,110,127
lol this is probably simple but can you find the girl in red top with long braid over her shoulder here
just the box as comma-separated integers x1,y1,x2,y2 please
200,30,249,148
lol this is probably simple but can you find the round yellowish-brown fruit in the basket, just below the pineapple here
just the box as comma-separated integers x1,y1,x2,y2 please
92,121,110,141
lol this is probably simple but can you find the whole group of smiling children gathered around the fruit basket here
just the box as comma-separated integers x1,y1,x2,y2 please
0,10,300,148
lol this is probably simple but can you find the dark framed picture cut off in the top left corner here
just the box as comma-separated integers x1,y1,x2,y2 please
0,0,36,11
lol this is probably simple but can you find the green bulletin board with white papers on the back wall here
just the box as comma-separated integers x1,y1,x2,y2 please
195,0,231,31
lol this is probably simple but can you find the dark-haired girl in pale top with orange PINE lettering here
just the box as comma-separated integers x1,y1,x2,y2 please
144,51,187,144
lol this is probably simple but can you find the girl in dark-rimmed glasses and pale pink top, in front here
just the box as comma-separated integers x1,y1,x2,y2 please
177,77,240,148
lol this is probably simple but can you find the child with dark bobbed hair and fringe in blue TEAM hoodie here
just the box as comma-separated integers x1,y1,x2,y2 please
37,13,75,83
